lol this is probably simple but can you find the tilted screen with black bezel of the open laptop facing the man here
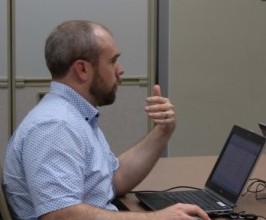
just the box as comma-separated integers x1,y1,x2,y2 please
206,127,264,203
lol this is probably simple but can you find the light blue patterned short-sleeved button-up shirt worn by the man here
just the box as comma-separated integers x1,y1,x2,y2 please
4,82,119,219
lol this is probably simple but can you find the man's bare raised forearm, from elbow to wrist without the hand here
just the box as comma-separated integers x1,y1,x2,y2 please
113,124,171,195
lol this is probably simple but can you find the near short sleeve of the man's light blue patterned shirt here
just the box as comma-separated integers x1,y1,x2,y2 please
22,121,86,216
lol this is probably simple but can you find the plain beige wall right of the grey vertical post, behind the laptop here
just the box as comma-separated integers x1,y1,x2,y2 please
169,0,266,155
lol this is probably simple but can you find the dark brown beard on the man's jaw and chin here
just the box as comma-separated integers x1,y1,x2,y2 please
90,69,118,106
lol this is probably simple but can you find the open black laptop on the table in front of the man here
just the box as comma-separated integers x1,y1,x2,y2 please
136,125,266,216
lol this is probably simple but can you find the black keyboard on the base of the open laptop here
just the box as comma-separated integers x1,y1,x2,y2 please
166,190,225,210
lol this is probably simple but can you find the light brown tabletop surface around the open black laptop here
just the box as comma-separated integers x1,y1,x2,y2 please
120,154,266,217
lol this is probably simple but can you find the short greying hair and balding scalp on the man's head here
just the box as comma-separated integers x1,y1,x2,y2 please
45,20,112,79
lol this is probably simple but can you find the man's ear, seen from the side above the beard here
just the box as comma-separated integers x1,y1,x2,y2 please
73,60,92,81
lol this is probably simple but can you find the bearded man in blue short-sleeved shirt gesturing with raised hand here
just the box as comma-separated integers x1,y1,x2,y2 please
4,21,208,220
